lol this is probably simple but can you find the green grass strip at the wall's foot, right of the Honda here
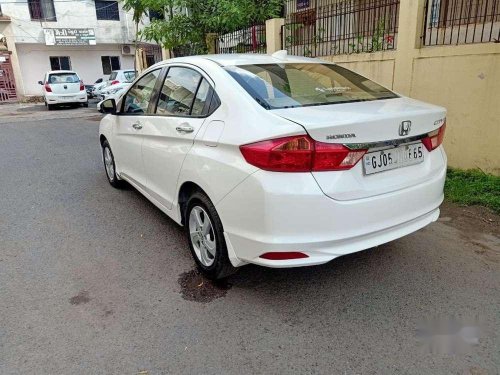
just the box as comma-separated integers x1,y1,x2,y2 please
444,169,500,214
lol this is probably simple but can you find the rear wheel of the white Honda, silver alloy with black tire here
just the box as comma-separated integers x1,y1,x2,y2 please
184,191,237,280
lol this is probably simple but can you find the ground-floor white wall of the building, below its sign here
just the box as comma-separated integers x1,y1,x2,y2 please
17,44,134,95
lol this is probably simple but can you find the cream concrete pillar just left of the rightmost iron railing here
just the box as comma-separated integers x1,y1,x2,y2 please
393,0,425,95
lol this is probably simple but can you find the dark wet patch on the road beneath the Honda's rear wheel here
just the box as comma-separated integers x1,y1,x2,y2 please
179,270,232,303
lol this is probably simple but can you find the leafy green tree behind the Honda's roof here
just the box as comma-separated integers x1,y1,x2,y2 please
141,0,283,53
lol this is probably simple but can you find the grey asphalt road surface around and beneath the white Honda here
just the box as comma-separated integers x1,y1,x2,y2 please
0,109,500,374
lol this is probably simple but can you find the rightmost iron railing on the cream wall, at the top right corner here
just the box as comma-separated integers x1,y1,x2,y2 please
422,0,500,46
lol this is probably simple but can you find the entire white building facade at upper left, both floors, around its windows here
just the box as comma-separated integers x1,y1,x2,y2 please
0,0,156,95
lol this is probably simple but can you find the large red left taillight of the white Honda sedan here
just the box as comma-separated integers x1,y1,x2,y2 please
240,135,367,172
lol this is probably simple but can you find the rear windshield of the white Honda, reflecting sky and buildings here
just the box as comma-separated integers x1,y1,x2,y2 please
225,63,398,109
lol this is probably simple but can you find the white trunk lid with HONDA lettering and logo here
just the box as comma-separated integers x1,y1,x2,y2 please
272,98,446,200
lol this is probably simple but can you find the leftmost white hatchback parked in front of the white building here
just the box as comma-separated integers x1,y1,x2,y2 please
38,70,89,110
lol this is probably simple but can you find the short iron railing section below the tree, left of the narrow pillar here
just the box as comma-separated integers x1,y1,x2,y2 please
215,24,267,53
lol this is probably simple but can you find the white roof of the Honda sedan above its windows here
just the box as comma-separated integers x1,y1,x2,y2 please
156,51,325,66
